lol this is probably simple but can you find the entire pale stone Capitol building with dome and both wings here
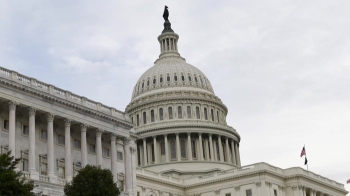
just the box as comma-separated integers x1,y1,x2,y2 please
0,8,347,196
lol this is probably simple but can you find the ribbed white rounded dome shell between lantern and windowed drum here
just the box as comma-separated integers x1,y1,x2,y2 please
132,56,214,100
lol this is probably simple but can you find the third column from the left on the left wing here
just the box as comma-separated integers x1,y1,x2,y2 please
46,113,57,183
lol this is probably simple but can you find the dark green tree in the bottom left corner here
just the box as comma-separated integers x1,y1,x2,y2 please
0,151,35,196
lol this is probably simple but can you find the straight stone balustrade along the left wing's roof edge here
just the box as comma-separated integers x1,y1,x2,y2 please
0,67,128,121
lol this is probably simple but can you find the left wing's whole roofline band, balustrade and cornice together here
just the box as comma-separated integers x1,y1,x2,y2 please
0,74,133,129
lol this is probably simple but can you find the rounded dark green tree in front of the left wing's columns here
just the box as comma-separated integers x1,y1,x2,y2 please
64,165,120,196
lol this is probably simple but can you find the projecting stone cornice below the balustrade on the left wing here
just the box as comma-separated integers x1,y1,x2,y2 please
0,75,134,129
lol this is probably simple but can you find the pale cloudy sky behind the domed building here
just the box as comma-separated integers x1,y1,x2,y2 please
0,0,350,193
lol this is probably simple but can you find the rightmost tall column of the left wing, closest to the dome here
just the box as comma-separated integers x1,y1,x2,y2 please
124,138,132,193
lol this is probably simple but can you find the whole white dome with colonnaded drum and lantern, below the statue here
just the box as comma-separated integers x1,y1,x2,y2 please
126,14,241,175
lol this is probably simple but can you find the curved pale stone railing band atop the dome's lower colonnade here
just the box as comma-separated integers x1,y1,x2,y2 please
134,119,238,134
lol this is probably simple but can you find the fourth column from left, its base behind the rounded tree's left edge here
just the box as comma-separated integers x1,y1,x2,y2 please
64,119,73,182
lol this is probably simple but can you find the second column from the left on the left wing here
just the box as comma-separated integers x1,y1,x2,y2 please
28,107,39,180
